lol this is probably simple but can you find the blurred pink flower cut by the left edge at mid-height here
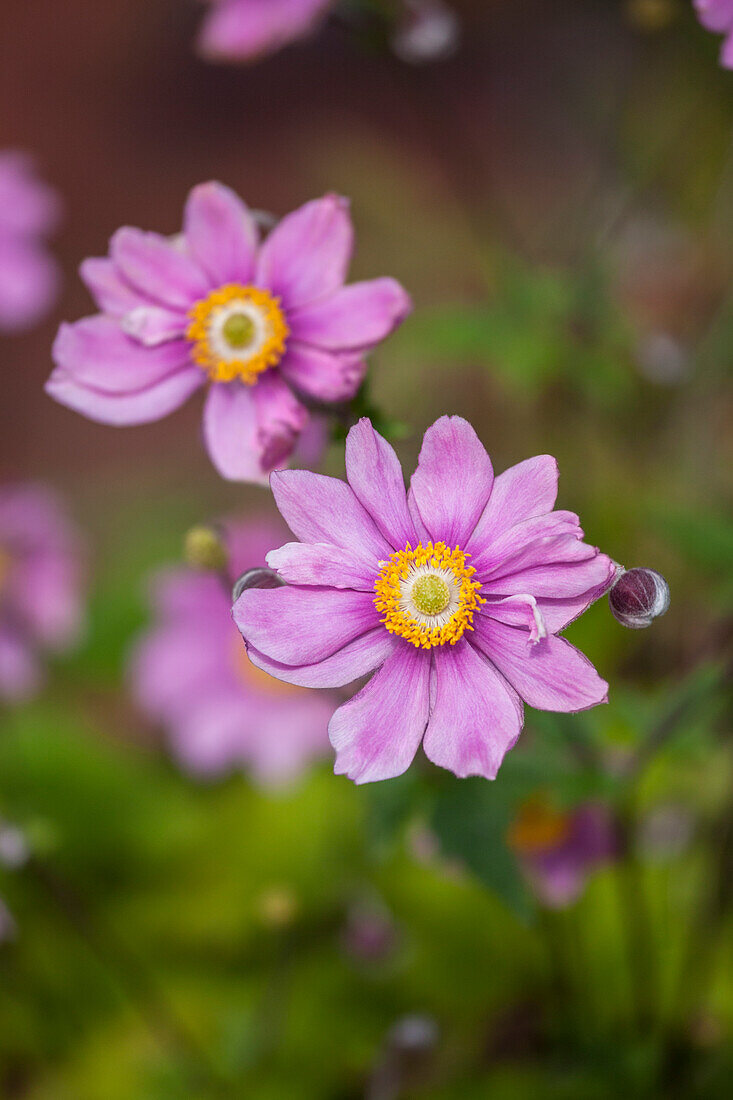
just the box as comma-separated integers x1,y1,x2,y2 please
0,484,83,702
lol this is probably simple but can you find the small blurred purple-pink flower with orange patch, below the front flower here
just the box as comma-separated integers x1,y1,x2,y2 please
508,799,619,909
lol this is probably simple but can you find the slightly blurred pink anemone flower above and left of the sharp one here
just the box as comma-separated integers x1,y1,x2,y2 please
46,183,411,482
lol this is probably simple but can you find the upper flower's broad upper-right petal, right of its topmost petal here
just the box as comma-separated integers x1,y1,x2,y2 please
256,195,353,310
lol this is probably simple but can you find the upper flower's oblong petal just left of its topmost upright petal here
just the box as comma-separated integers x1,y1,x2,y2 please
109,227,211,310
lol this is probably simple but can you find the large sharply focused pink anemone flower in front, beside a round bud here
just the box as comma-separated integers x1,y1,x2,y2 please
233,417,615,782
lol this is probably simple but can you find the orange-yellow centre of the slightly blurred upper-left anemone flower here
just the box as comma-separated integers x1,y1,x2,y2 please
186,283,289,386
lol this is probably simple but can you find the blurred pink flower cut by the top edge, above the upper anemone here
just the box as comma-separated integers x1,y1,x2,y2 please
193,0,333,62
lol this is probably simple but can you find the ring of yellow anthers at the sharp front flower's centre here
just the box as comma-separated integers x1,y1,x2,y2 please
374,542,485,649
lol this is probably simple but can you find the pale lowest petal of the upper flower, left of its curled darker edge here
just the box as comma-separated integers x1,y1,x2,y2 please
204,382,267,485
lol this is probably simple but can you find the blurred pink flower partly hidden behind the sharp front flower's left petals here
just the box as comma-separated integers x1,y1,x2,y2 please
131,521,332,784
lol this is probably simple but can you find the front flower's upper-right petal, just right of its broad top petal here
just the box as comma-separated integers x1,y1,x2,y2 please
464,454,558,556
